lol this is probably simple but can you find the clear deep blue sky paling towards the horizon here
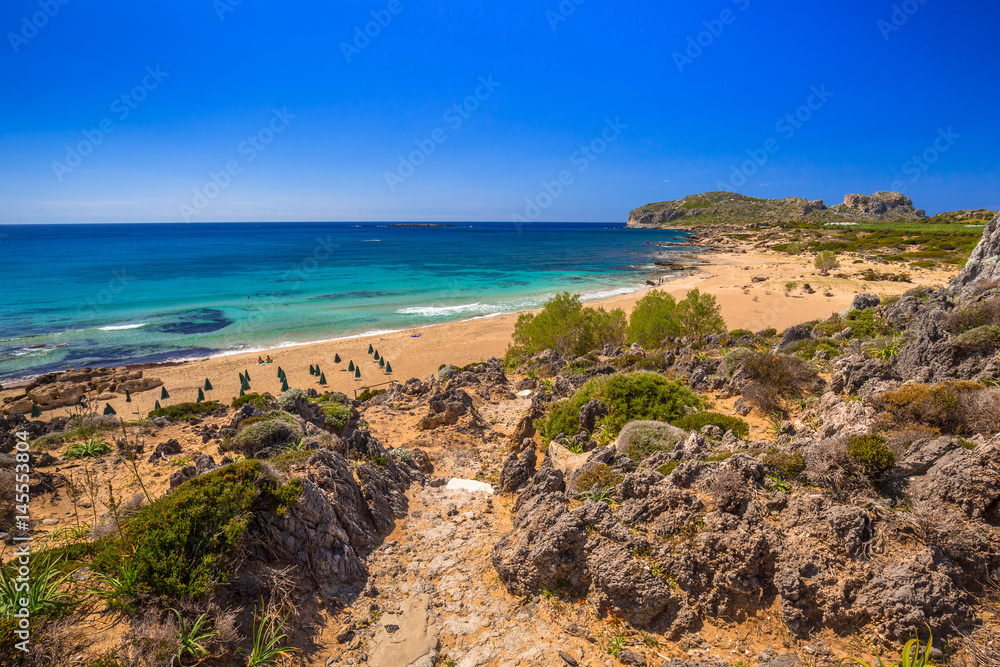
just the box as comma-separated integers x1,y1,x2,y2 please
0,0,1000,223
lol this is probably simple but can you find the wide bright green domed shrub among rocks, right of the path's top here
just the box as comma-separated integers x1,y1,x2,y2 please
541,372,704,440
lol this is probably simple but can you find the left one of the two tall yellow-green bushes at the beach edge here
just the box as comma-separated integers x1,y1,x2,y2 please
508,292,627,357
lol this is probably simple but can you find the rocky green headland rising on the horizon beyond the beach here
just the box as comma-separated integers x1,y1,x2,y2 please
628,191,948,227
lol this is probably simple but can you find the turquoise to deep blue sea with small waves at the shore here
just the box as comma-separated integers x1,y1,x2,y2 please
0,223,686,379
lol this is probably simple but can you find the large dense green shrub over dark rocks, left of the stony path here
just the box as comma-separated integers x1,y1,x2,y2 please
94,460,301,601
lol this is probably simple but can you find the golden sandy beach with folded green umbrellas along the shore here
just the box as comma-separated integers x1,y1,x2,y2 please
0,246,950,415
